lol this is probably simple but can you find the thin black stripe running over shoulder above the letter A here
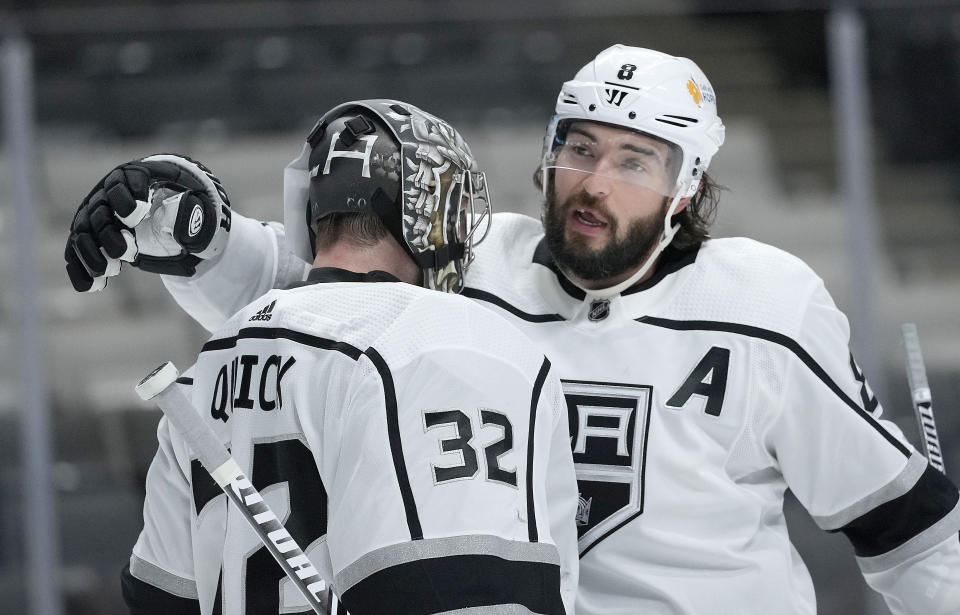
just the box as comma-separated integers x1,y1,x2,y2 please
636,316,912,457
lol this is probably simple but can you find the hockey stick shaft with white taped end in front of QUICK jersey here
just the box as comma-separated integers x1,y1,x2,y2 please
136,361,328,615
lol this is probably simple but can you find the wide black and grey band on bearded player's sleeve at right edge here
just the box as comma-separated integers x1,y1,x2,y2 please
838,465,960,569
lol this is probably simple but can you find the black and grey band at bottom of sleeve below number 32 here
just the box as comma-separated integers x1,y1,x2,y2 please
337,536,564,615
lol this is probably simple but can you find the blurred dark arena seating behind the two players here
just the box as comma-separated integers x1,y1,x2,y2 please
0,0,960,615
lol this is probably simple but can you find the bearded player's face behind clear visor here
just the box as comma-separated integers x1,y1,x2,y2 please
544,122,679,281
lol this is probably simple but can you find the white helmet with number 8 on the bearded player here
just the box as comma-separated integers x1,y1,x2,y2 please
541,45,724,198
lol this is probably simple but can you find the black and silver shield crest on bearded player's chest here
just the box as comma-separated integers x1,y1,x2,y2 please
563,380,652,555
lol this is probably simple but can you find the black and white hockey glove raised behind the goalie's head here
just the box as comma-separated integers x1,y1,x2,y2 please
64,154,230,292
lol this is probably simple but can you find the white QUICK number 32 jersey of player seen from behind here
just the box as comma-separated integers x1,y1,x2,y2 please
124,268,577,615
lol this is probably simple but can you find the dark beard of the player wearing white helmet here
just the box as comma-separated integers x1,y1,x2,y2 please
543,185,669,281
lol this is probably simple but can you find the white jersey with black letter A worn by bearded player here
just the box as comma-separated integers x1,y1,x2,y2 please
158,214,960,615
